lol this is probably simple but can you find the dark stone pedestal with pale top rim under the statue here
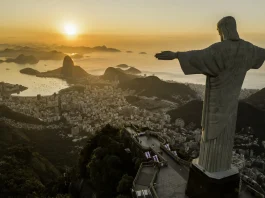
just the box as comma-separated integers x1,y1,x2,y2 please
186,160,240,198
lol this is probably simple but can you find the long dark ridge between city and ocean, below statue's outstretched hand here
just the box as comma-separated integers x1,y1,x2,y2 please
119,76,197,103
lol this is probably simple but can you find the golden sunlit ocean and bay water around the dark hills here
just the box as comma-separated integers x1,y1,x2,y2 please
0,52,265,96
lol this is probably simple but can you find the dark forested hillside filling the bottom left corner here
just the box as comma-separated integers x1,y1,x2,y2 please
0,142,60,197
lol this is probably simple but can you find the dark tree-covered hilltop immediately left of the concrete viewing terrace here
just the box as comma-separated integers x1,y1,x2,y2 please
76,125,136,198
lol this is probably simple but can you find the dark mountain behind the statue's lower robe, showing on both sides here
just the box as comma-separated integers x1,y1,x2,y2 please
168,100,265,139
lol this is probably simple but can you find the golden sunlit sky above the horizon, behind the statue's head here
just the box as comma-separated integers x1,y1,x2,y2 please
0,0,265,49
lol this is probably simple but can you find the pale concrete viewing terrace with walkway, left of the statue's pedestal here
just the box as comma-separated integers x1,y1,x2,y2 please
126,127,262,198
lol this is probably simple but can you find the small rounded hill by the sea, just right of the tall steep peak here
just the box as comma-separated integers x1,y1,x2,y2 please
101,67,136,82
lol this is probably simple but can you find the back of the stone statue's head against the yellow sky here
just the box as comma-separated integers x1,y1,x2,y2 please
217,16,240,41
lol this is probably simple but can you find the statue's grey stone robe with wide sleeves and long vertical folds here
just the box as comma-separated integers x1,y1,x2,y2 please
178,40,265,172
